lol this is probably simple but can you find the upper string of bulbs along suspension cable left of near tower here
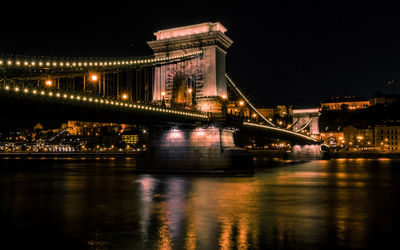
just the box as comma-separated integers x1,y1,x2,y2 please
0,51,203,68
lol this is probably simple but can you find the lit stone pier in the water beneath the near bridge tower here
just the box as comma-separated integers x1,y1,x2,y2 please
136,128,254,174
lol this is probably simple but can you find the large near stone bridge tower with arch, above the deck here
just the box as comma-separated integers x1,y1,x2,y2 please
148,22,233,112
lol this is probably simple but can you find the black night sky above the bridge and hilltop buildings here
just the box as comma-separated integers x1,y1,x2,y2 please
0,0,400,107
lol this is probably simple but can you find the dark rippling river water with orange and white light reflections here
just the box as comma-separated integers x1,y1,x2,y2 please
0,158,400,249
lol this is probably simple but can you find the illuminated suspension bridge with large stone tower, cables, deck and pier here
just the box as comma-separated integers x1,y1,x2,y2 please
0,22,318,173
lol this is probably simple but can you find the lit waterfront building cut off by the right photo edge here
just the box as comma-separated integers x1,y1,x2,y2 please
375,122,400,151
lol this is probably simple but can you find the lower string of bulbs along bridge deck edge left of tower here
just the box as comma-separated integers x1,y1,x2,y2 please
4,85,208,119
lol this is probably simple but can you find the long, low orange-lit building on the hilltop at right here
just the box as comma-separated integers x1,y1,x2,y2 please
321,96,369,110
